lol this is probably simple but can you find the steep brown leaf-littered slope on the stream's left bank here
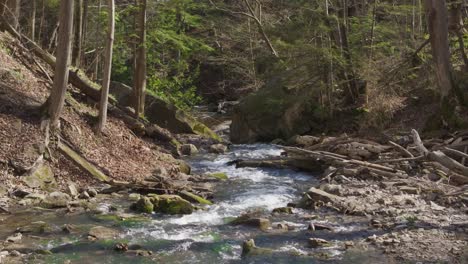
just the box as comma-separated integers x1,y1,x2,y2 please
0,30,182,204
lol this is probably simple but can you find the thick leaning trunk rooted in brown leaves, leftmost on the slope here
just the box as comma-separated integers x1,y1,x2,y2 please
49,0,74,129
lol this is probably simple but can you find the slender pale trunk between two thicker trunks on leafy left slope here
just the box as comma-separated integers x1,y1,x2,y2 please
98,0,115,133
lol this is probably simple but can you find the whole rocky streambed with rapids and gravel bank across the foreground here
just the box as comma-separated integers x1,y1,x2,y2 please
0,145,467,263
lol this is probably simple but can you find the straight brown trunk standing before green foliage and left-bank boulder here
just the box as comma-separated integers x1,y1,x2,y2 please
134,0,147,118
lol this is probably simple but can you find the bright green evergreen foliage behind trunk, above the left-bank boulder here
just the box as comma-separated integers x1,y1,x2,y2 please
112,0,213,109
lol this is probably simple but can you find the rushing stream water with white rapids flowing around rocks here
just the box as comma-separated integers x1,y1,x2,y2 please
0,145,385,263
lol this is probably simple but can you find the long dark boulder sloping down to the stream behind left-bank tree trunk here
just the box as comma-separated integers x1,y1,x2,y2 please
110,82,220,141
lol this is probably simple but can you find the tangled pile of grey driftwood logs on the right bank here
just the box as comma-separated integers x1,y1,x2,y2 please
233,130,468,188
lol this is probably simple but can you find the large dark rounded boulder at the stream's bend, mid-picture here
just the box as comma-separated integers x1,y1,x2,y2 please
231,75,325,143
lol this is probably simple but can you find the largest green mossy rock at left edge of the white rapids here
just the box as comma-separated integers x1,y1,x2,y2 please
148,195,194,215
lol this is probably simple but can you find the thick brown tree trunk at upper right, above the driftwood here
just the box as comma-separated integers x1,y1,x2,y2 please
424,0,452,99
